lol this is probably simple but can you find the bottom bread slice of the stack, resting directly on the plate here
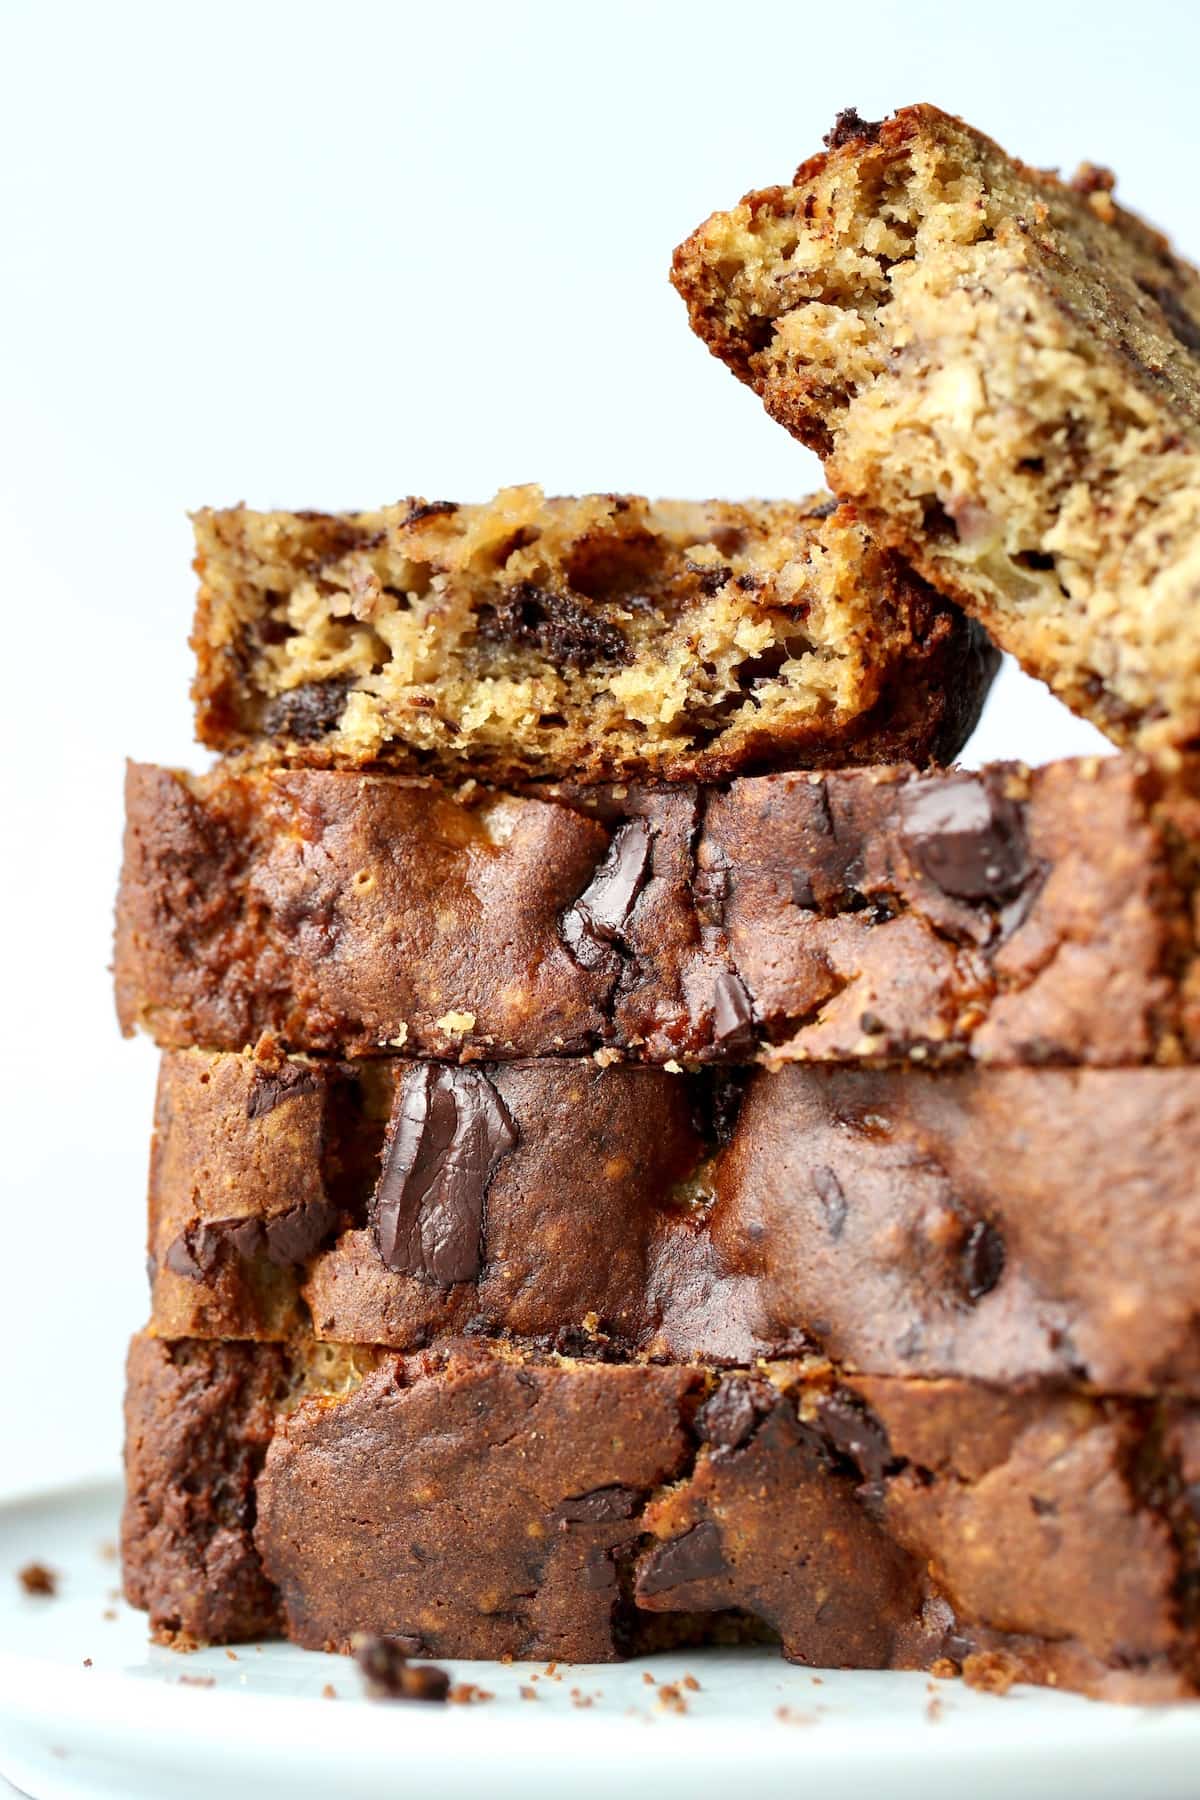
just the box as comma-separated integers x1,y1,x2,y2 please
124,1341,1200,1701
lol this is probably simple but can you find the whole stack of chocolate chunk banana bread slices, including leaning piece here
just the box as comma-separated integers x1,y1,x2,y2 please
115,108,1200,1699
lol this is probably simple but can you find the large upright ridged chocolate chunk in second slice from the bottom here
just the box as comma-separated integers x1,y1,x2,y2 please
372,1064,516,1287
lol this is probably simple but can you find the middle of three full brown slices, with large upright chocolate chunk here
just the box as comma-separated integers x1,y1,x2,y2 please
149,1051,1200,1399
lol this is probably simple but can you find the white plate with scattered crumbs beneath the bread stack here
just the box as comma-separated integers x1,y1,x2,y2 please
0,1483,1200,1800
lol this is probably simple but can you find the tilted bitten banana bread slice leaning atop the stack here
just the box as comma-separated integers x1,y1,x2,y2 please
673,106,1200,747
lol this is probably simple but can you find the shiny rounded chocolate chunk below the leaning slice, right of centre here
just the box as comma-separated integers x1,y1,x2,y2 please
901,774,1033,902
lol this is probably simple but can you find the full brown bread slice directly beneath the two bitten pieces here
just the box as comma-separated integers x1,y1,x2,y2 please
115,758,1200,1066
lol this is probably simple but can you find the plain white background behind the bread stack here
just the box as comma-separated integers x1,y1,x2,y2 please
0,0,1200,1490
